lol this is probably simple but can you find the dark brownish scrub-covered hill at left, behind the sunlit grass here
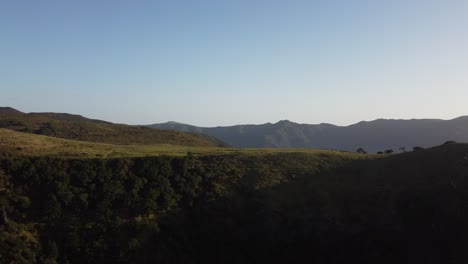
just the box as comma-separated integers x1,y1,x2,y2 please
0,108,225,147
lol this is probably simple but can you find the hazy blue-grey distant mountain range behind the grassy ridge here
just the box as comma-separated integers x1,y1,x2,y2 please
150,117,468,153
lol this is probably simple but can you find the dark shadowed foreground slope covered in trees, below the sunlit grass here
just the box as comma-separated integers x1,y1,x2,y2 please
0,144,468,263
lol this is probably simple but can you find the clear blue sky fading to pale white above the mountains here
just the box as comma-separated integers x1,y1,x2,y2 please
0,0,468,126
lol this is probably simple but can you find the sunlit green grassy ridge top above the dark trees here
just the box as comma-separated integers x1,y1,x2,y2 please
0,128,361,159
